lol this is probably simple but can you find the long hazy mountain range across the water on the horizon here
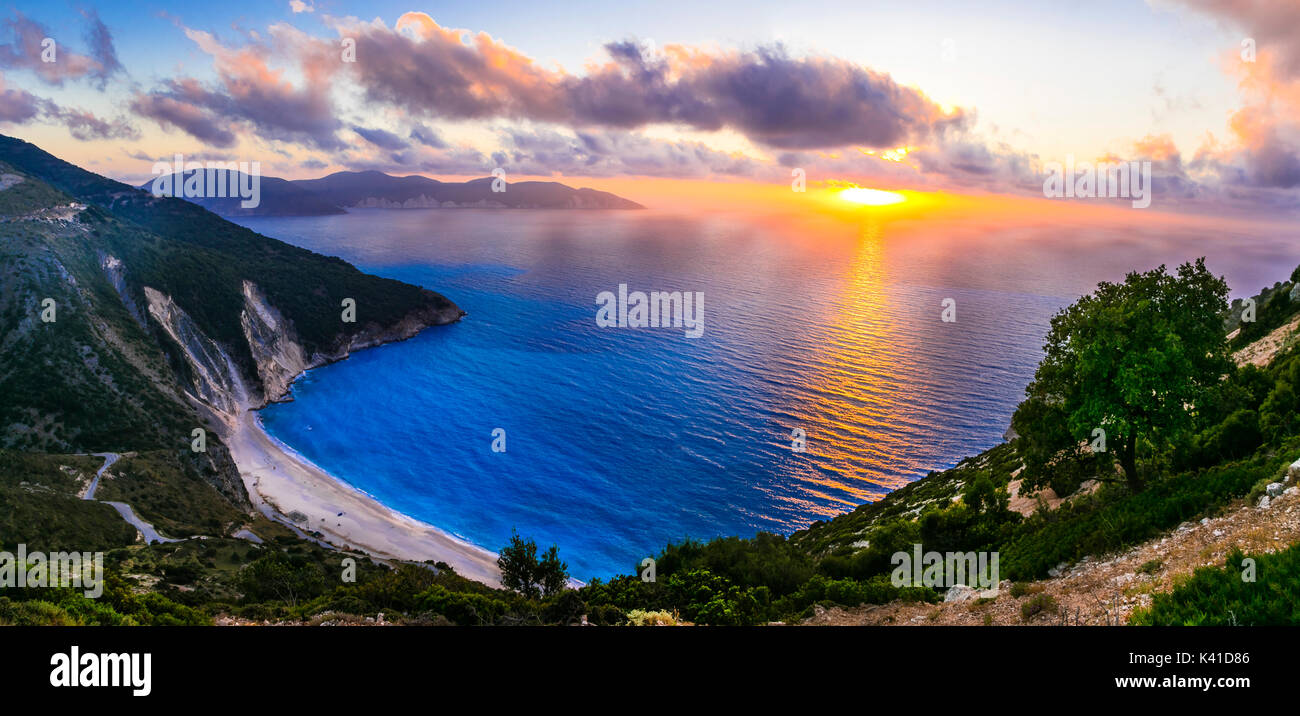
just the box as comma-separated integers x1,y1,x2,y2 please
140,170,645,216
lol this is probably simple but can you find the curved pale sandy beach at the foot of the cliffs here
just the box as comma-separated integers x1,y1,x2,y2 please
226,409,501,586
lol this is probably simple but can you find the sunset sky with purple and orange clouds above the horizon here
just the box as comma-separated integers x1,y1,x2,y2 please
0,0,1300,216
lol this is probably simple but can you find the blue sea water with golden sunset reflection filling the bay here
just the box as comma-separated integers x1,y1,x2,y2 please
239,209,1300,580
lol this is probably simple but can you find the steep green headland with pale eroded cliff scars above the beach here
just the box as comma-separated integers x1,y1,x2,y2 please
0,136,462,558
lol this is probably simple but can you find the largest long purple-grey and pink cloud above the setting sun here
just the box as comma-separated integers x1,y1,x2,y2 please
337,13,965,149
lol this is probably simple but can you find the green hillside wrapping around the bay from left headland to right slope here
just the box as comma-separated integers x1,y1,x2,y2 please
0,139,1300,625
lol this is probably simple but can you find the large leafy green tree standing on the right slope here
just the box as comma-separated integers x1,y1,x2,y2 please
1013,257,1231,491
